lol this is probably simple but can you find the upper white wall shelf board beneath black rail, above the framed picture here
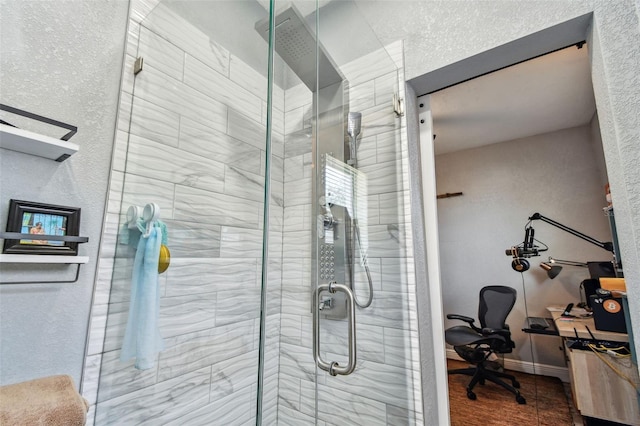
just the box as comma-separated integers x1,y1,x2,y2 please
0,124,79,162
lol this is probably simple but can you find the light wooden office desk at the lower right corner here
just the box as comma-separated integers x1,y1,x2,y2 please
547,306,640,425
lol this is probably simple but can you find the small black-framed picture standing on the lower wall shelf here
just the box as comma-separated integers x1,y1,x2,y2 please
2,200,80,256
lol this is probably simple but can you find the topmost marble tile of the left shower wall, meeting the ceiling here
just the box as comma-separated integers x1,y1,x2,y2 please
143,4,230,76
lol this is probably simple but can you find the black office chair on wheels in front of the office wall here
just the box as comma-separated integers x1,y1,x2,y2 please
444,285,526,404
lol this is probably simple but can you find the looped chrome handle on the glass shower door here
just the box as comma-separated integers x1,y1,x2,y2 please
313,283,356,376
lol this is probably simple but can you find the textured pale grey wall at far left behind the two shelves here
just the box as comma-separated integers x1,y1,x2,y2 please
0,0,128,384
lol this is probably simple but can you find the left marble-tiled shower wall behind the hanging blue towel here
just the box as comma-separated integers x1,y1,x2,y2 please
82,0,284,425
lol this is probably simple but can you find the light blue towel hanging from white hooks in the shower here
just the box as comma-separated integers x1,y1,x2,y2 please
120,222,164,370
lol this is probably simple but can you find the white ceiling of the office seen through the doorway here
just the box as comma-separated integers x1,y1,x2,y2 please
431,45,596,155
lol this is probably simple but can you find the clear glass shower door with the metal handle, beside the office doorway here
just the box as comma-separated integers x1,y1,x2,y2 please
275,1,423,425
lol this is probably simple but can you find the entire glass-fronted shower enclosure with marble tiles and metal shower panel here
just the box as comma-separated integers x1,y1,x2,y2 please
82,0,423,425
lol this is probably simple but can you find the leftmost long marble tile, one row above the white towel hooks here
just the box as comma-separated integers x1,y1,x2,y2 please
125,135,224,192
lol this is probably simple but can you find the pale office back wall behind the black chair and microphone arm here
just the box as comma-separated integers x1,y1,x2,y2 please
436,126,611,367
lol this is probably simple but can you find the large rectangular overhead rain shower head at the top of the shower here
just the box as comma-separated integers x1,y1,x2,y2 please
255,4,344,91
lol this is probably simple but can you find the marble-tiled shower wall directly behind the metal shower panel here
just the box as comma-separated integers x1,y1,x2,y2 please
278,39,423,425
